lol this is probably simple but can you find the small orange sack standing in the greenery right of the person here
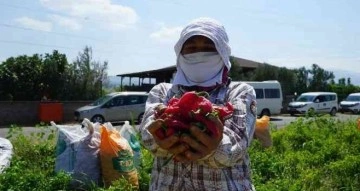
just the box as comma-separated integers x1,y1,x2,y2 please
254,115,272,148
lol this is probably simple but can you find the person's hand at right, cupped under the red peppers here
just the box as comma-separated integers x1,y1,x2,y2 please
175,117,224,163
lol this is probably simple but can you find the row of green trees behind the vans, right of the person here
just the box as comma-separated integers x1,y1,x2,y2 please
230,59,360,101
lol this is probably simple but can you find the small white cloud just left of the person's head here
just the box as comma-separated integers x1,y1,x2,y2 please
150,26,183,43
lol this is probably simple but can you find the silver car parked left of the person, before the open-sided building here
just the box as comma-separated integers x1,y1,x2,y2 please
74,92,148,123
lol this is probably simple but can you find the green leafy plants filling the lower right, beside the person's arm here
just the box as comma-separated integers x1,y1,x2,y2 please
250,116,360,191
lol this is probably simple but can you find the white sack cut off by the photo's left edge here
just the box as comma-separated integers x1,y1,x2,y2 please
0,137,13,173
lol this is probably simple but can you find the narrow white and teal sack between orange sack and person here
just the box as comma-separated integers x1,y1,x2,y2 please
119,121,141,168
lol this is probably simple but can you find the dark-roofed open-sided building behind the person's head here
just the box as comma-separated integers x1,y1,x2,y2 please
116,56,262,91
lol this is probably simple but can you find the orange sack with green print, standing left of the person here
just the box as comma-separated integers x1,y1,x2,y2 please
100,125,139,187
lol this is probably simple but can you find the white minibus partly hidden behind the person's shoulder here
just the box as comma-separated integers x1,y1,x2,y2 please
242,80,283,117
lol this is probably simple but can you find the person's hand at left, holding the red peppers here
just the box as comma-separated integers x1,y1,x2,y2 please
148,119,189,155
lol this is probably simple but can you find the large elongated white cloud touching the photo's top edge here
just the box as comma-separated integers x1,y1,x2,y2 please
40,0,138,29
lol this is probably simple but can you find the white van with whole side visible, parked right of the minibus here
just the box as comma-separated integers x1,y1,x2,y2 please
287,92,338,116
